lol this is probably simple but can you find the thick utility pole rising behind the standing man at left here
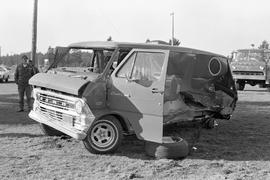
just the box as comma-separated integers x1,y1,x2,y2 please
31,0,38,66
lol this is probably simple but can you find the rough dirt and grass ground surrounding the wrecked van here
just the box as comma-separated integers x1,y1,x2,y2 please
0,83,270,180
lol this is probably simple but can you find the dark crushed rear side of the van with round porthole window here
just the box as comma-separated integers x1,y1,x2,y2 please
164,52,237,123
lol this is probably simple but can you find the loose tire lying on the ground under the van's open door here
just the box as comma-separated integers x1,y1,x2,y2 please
145,137,189,159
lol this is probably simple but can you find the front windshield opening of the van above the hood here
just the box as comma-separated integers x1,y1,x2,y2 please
51,49,114,74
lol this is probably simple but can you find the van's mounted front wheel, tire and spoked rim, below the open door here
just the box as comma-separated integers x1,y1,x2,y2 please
83,116,123,154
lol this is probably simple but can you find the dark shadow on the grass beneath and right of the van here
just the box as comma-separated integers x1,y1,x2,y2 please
80,112,270,161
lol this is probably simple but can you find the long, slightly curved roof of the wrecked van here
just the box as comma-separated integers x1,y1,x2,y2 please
69,41,224,57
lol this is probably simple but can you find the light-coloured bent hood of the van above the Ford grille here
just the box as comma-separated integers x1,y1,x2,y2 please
29,73,90,95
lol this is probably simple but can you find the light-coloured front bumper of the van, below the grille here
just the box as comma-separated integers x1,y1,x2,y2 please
29,110,86,140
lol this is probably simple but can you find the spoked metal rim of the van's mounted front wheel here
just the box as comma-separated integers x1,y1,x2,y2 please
91,123,117,148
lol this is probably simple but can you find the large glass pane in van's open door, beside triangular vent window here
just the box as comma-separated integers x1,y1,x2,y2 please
130,52,165,87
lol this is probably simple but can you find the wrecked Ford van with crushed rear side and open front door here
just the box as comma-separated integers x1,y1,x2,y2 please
29,41,237,153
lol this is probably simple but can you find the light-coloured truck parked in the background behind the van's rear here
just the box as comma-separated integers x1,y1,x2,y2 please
231,49,270,91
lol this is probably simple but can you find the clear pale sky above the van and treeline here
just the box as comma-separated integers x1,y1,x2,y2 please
0,0,270,56
